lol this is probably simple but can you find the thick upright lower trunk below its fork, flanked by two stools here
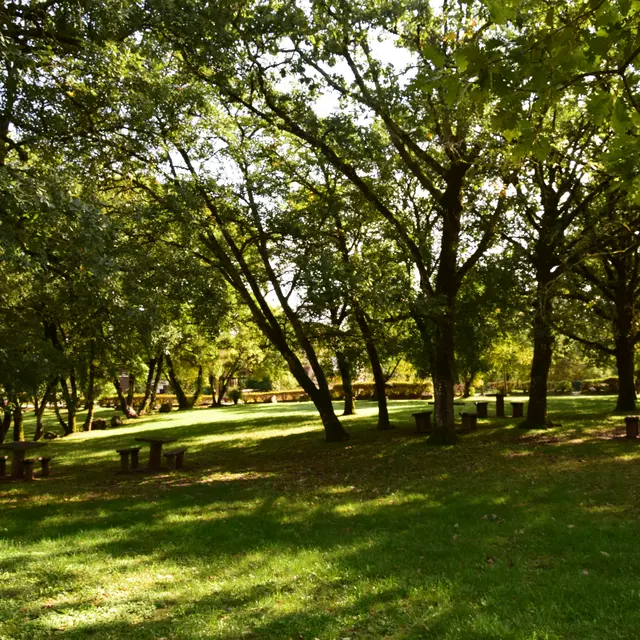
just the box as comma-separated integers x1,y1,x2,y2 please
429,312,458,445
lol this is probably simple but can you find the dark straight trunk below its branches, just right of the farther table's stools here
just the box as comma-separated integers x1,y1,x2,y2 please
520,279,555,429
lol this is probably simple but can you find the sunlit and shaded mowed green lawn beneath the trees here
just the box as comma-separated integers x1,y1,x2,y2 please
0,397,640,640
